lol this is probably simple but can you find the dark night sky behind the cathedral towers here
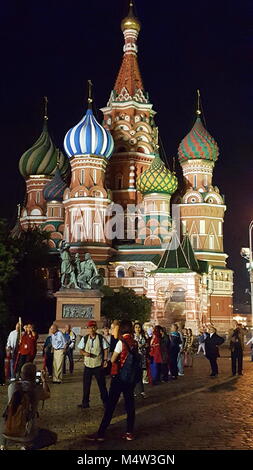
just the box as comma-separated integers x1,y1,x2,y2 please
0,0,253,301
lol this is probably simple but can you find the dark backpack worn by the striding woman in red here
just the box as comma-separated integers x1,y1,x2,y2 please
119,339,142,385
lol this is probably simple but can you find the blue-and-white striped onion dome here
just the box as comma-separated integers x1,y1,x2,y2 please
64,109,114,158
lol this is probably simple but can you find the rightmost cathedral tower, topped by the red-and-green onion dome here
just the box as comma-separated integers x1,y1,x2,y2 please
178,92,233,330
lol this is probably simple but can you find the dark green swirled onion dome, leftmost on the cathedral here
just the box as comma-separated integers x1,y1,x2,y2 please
19,120,69,179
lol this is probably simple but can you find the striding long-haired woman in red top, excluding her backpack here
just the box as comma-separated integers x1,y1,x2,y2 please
86,320,138,442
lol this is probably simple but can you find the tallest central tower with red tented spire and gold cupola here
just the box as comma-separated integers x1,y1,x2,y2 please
101,1,155,209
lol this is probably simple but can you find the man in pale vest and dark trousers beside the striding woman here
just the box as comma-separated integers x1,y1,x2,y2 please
77,320,109,408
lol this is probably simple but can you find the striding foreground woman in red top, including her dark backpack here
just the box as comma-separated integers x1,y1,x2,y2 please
86,320,141,442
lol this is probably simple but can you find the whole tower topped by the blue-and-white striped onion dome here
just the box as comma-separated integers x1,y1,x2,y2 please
63,81,114,261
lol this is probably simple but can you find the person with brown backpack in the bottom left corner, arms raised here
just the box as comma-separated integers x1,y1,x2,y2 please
0,362,50,450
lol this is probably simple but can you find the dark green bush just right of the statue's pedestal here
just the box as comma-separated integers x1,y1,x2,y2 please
102,286,152,323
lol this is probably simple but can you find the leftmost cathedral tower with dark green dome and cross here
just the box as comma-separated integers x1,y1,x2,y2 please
19,97,69,229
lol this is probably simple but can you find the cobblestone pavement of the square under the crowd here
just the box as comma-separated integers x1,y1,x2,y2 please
0,348,253,450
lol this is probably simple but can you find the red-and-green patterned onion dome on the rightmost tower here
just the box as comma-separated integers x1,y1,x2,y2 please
178,117,219,163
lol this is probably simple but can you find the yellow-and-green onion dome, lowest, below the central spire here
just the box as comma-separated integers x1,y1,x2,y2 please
136,155,178,194
